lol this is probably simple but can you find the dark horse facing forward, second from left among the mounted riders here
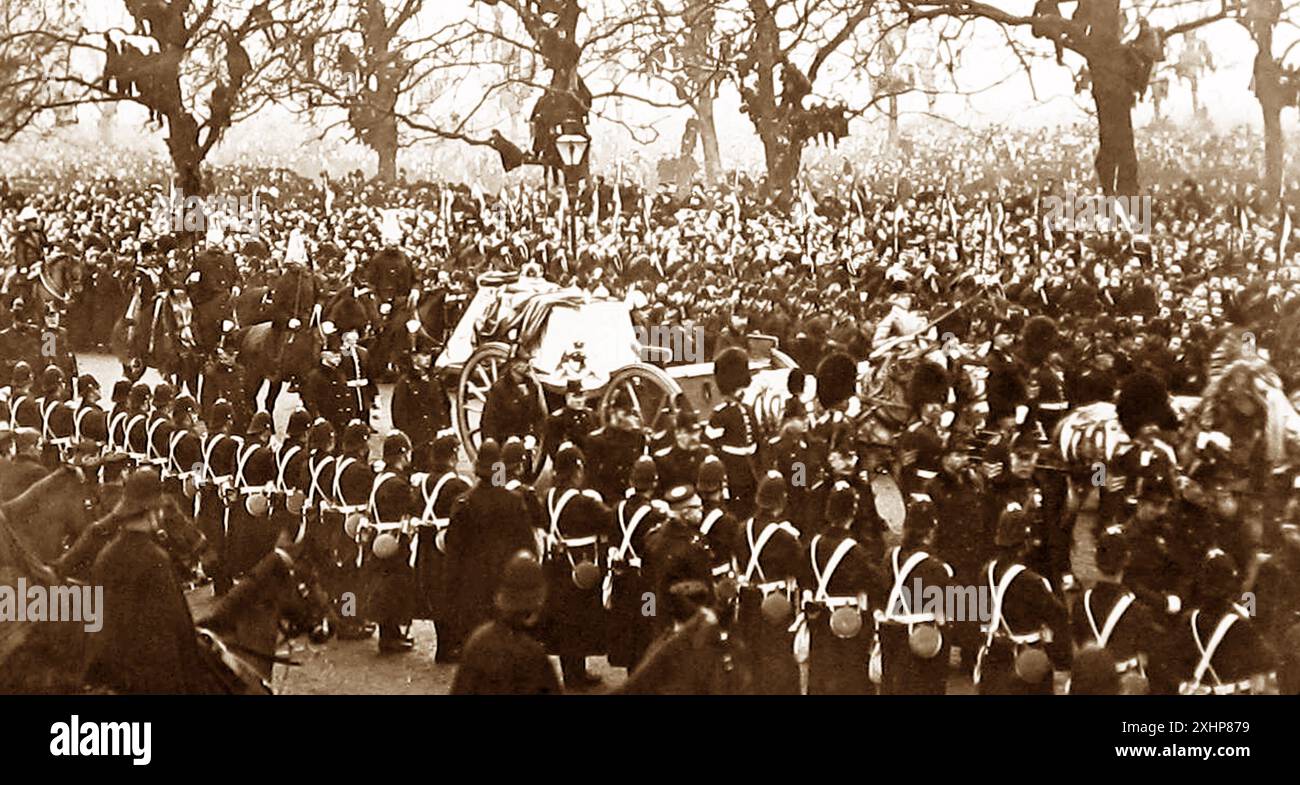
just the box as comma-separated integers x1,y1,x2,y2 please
112,269,195,382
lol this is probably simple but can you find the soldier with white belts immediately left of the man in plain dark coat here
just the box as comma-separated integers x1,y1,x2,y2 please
411,433,471,663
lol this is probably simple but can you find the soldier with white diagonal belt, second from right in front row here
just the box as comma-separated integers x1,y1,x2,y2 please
1070,526,1177,694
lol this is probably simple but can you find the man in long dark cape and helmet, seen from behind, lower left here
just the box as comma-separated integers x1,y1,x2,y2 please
86,469,204,694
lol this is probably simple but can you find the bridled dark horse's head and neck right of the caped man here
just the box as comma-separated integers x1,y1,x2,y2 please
195,543,334,694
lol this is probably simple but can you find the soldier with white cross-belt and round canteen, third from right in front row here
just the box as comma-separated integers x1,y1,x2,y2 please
975,503,1070,695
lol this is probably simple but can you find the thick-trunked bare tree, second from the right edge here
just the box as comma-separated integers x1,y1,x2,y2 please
898,0,1230,195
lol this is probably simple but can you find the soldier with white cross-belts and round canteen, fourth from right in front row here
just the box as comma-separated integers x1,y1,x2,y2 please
876,494,956,695
